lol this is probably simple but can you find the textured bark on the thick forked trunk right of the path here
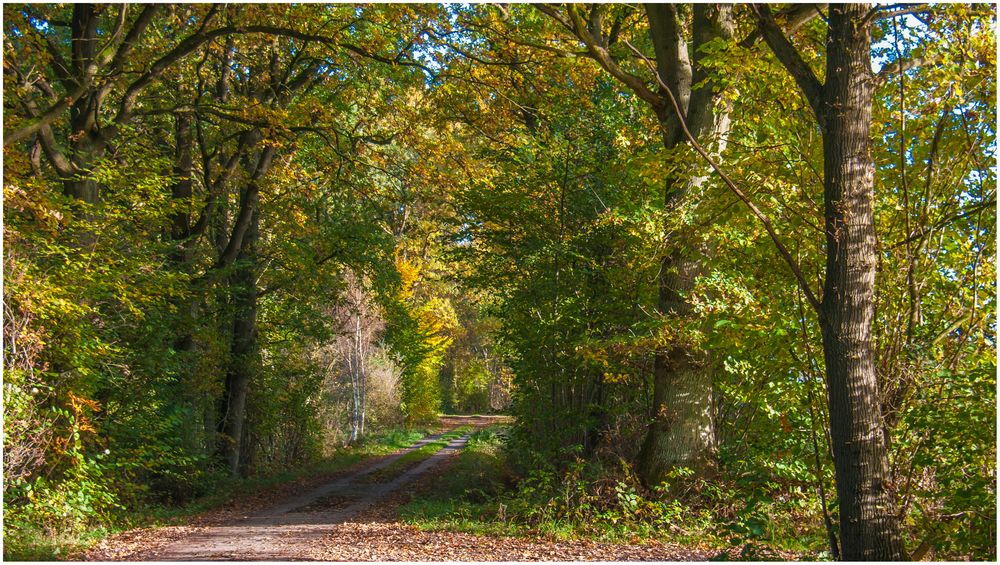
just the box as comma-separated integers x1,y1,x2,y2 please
638,4,733,486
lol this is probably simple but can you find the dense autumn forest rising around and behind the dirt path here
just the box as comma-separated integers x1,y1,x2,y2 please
3,4,997,559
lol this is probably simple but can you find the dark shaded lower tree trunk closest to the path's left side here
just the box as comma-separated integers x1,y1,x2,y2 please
220,210,259,476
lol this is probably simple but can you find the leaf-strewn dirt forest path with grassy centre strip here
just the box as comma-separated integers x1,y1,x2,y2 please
85,416,712,561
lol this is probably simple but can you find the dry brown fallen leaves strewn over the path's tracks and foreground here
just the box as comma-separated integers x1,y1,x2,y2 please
80,414,718,561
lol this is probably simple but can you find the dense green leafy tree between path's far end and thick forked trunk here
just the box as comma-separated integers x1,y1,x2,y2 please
453,68,662,464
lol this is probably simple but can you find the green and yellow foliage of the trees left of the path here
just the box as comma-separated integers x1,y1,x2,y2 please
4,5,450,555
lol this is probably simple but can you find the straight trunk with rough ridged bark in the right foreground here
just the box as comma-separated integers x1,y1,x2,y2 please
821,5,906,561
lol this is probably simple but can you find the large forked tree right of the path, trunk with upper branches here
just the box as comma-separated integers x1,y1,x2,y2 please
539,4,815,485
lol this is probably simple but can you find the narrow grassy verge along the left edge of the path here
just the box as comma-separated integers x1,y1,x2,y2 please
3,429,436,561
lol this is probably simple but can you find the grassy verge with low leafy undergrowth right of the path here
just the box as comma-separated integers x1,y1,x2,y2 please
400,426,823,560
